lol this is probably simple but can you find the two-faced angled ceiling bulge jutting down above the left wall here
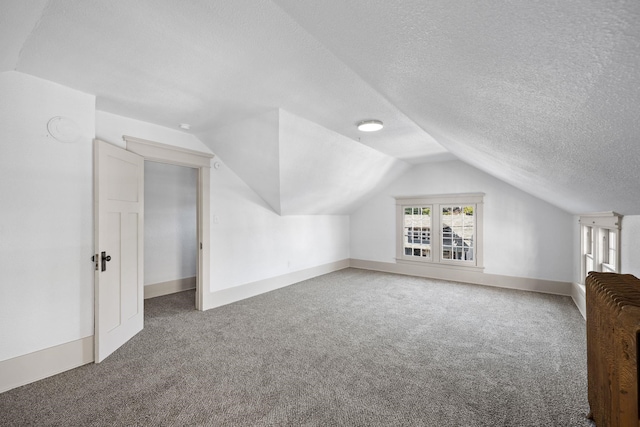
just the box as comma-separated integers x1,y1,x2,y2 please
205,109,410,215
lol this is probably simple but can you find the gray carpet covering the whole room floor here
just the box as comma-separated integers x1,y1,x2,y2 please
0,269,593,427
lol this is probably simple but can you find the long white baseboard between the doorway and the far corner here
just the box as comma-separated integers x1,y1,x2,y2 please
205,259,349,310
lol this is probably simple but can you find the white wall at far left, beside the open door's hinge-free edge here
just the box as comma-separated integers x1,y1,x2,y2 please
0,71,95,361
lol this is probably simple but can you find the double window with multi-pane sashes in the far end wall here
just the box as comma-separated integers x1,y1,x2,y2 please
396,194,484,267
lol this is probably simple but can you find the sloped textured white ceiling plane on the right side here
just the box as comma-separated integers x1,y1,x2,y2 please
275,0,640,214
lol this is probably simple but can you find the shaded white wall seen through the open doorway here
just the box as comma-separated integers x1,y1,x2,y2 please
144,161,198,285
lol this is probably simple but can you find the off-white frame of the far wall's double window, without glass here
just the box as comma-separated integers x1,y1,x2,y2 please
395,193,484,270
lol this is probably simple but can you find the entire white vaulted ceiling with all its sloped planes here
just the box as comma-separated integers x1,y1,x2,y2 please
0,0,640,214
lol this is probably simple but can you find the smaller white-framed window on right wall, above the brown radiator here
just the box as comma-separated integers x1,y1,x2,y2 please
580,212,622,284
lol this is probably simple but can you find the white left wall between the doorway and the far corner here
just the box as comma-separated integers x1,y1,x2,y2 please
210,158,349,291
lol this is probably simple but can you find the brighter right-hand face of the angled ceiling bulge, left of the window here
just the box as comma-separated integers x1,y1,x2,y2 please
280,110,409,215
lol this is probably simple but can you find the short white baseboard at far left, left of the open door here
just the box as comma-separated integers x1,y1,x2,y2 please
0,335,94,393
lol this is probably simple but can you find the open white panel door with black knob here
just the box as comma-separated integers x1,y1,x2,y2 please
94,140,144,363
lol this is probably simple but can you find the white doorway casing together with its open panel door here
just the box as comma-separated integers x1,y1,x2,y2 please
92,136,213,363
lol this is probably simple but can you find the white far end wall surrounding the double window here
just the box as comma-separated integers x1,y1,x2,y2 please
351,161,574,282
